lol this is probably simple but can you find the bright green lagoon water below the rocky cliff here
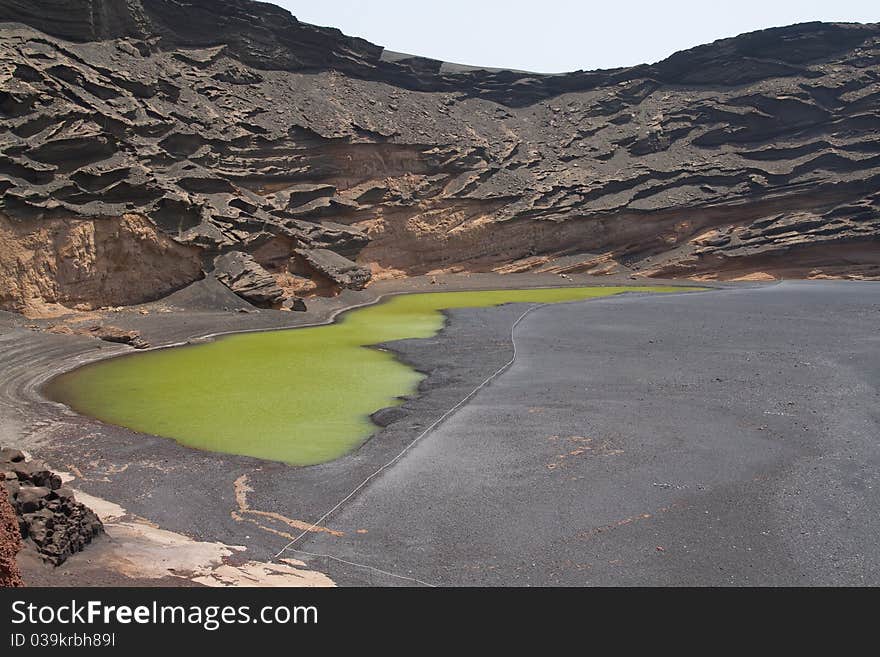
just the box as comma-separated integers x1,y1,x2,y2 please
45,287,682,465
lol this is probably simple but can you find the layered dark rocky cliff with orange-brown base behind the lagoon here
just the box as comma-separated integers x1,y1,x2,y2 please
0,0,880,312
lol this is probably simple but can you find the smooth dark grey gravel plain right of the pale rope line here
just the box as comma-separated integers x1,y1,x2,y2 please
301,282,880,585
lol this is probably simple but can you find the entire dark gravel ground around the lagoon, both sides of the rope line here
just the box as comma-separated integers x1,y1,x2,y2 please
6,277,880,585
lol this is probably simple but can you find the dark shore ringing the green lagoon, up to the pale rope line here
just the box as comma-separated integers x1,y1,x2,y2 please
0,275,720,584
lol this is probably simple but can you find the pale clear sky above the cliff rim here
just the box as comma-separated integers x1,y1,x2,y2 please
274,0,880,73
